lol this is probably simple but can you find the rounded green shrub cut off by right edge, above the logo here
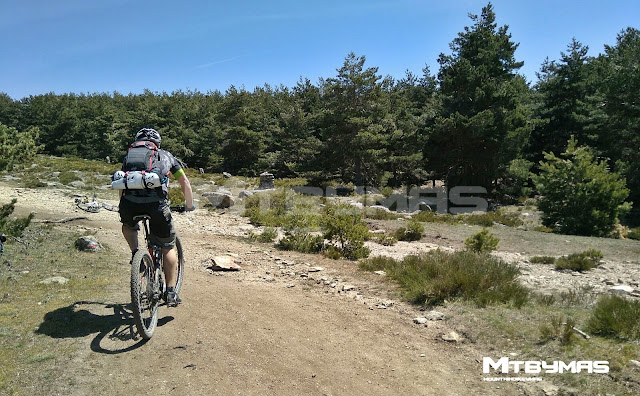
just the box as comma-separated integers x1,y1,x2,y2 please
587,295,640,340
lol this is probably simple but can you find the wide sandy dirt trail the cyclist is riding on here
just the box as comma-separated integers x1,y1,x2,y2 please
0,185,538,395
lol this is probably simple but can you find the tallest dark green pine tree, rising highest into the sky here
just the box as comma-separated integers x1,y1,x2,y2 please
425,4,531,189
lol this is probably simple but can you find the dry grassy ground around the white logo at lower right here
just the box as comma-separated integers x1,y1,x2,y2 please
447,298,640,395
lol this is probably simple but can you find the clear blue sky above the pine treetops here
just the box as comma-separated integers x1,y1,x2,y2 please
0,0,640,99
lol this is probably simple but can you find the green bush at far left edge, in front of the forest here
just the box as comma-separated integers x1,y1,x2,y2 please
0,123,40,171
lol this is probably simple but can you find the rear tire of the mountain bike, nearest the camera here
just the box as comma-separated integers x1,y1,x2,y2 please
131,249,159,340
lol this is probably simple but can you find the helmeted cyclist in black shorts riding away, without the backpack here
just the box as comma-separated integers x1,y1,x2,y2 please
119,128,196,307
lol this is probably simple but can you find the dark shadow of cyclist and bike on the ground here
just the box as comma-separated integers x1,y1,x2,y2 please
36,301,173,354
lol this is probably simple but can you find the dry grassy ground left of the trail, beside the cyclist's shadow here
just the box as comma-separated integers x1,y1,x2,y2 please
0,225,124,395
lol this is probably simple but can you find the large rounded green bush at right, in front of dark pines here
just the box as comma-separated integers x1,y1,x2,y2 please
533,137,631,236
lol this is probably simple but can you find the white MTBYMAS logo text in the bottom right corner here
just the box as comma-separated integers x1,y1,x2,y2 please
482,357,609,374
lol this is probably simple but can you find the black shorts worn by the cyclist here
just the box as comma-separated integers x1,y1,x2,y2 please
119,198,176,249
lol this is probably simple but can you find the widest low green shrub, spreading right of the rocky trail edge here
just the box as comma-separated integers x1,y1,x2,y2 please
360,250,529,307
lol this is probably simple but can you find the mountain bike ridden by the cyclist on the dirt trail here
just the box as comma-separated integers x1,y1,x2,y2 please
131,206,185,340
